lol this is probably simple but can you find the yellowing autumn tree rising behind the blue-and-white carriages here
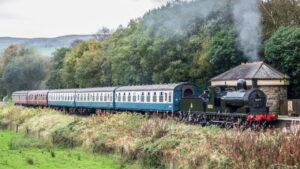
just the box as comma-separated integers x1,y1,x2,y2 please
62,40,111,88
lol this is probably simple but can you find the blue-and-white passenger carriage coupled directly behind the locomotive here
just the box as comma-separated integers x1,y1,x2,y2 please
115,83,199,111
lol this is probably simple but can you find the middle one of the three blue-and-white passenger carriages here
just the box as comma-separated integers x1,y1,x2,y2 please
76,87,116,109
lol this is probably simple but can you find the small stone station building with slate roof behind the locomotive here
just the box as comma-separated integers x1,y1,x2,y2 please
211,62,290,113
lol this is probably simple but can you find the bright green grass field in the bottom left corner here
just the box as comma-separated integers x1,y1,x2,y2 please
0,130,123,169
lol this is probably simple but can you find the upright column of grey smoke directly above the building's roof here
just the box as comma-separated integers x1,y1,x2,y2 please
233,0,261,61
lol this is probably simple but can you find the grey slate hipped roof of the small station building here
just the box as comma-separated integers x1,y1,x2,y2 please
211,62,290,81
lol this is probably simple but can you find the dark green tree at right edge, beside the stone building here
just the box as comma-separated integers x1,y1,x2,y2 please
265,27,300,98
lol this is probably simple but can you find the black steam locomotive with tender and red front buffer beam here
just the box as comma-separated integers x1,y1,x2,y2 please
179,79,277,126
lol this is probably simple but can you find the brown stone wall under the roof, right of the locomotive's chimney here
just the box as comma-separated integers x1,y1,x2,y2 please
259,86,287,114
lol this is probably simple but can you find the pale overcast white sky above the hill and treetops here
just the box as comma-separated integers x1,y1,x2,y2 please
0,0,164,37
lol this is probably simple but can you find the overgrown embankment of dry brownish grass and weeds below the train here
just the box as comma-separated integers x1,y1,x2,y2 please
0,106,300,169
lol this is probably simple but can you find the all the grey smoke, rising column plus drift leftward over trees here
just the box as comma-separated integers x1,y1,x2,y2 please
147,0,261,61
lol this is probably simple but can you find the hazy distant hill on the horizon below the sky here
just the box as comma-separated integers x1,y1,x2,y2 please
0,35,93,56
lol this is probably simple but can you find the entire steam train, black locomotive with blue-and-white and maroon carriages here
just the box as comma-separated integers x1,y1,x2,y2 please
12,79,277,127
